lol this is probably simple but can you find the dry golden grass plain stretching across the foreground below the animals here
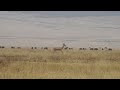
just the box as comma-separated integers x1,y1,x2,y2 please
0,49,120,79
